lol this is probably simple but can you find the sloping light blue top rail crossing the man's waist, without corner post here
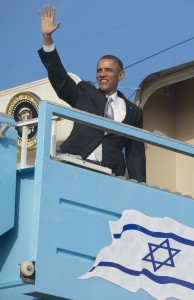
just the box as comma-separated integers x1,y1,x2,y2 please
46,102,194,157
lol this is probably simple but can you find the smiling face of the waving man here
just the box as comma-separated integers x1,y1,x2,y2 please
96,59,124,95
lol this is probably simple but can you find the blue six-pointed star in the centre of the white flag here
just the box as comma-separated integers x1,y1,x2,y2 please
142,239,181,272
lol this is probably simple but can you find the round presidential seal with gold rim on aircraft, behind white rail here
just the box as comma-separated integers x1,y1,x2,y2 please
6,92,40,149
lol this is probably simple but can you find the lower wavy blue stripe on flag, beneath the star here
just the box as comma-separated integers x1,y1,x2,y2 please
89,261,194,290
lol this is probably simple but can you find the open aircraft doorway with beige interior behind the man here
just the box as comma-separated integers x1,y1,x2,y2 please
135,62,194,197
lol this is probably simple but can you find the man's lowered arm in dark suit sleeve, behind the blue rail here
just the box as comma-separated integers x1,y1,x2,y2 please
125,107,146,182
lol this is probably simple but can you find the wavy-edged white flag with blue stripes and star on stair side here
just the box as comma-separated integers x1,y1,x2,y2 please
79,210,194,300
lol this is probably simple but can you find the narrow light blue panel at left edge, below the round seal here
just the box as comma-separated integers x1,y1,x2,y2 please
0,114,17,236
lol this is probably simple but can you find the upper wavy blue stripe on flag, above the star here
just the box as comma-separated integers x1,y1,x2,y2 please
113,224,194,246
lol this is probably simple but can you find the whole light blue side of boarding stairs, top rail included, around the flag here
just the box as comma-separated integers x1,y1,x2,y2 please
0,102,194,300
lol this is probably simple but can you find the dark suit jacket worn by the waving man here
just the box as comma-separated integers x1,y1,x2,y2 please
39,49,146,182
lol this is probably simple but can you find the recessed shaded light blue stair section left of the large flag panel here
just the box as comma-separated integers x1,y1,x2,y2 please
0,168,36,300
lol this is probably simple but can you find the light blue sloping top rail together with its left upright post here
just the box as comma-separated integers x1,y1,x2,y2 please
38,101,194,162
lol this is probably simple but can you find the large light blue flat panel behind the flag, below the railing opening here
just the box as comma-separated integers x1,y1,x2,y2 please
32,159,194,300
